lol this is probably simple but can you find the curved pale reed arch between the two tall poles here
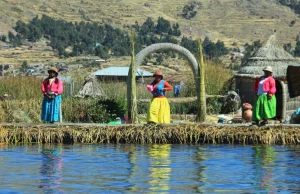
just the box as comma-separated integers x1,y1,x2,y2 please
127,43,201,122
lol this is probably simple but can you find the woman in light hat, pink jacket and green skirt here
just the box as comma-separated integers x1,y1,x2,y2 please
252,66,276,125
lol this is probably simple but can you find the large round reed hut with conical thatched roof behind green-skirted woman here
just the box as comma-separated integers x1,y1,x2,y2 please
234,34,300,121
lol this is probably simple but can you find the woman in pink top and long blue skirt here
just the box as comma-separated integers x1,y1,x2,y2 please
42,67,63,123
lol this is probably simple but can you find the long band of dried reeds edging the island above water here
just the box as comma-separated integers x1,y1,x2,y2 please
0,124,300,145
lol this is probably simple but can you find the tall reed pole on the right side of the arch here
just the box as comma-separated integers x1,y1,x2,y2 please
196,39,206,122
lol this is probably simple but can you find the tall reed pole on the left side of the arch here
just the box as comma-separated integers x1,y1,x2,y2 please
127,33,138,123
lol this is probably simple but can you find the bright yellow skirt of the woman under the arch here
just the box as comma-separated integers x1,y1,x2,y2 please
147,98,171,124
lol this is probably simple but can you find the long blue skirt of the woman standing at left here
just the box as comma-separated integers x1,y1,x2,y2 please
41,95,62,122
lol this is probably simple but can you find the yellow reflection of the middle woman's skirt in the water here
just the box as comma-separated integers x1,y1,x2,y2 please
148,144,171,193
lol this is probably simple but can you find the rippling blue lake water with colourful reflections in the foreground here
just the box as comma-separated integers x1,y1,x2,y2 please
0,144,300,193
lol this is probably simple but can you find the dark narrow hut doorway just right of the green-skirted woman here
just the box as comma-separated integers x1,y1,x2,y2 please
275,79,285,121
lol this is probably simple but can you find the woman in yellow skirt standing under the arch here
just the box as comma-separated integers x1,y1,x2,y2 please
147,72,173,124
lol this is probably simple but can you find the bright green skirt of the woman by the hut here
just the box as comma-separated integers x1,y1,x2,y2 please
252,94,276,121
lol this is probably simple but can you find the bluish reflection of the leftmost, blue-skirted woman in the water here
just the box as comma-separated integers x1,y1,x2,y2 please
39,145,63,193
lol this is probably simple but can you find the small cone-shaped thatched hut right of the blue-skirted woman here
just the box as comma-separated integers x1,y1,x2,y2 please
75,75,105,98
